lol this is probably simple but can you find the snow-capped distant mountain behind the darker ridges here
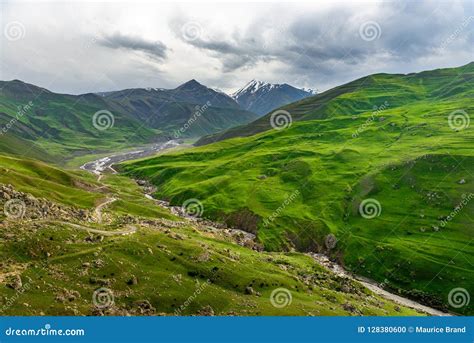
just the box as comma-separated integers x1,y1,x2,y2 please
231,80,316,115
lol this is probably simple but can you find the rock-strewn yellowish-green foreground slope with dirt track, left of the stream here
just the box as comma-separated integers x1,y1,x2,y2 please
0,156,419,315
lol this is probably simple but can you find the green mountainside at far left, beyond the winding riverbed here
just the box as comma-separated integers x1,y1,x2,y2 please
0,80,157,160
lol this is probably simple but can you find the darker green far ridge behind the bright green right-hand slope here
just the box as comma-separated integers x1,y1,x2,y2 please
197,62,474,145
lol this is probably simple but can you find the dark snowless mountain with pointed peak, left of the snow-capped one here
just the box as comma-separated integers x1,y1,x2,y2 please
98,80,258,137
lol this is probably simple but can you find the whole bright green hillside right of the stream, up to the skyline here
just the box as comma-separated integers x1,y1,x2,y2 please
123,63,474,314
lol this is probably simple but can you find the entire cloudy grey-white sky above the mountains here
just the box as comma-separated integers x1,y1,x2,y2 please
0,0,474,94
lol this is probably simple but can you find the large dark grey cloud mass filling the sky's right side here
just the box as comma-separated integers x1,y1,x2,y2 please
175,1,474,78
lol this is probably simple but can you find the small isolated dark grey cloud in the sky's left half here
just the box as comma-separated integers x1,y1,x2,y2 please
98,32,168,60
